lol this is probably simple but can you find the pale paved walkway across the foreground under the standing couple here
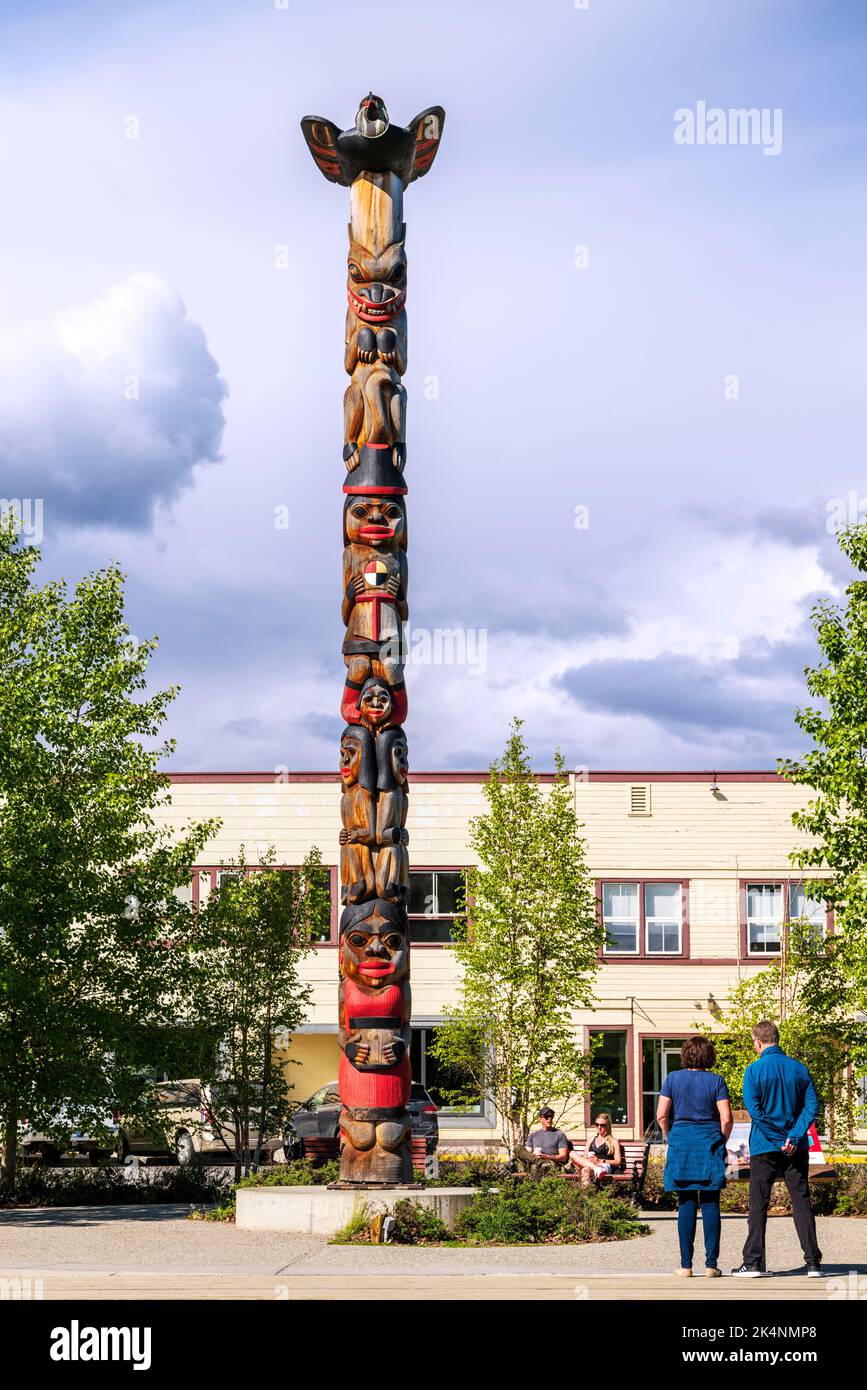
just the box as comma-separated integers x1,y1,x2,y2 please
0,1207,867,1302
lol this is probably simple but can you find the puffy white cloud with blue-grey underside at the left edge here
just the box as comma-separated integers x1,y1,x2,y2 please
0,275,228,534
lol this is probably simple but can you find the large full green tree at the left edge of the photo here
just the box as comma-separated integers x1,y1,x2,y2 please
0,525,215,1177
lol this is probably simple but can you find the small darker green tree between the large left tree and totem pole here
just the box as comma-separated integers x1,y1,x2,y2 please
196,845,331,1182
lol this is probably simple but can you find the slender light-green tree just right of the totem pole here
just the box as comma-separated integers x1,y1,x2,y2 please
431,720,604,1154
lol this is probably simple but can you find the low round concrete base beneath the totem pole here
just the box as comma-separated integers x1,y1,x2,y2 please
235,1187,478,1236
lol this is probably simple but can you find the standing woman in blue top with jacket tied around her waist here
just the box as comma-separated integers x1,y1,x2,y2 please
656,1036,732,1279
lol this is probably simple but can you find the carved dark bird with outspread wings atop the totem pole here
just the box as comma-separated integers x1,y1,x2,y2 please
302,92,446,188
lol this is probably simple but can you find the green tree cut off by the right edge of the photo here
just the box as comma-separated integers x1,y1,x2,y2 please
779,524,867,1128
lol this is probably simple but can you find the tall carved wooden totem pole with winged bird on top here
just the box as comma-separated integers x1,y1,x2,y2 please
302,93,446,1186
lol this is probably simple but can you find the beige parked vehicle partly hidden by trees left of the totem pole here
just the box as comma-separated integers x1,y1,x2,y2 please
117,1080,279,1166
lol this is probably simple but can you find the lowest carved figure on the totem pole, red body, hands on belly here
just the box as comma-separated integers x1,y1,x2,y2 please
338,898,413,1183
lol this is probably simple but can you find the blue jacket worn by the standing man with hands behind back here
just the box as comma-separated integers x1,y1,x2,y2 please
743,1047,818,1154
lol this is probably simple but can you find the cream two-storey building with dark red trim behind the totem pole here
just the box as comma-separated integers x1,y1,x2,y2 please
159,771,844,1147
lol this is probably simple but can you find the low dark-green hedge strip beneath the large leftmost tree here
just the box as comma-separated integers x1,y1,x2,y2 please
0,1163,229,1207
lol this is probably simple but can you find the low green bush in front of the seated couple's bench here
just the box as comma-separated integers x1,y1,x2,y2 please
454,1176,649,1245
